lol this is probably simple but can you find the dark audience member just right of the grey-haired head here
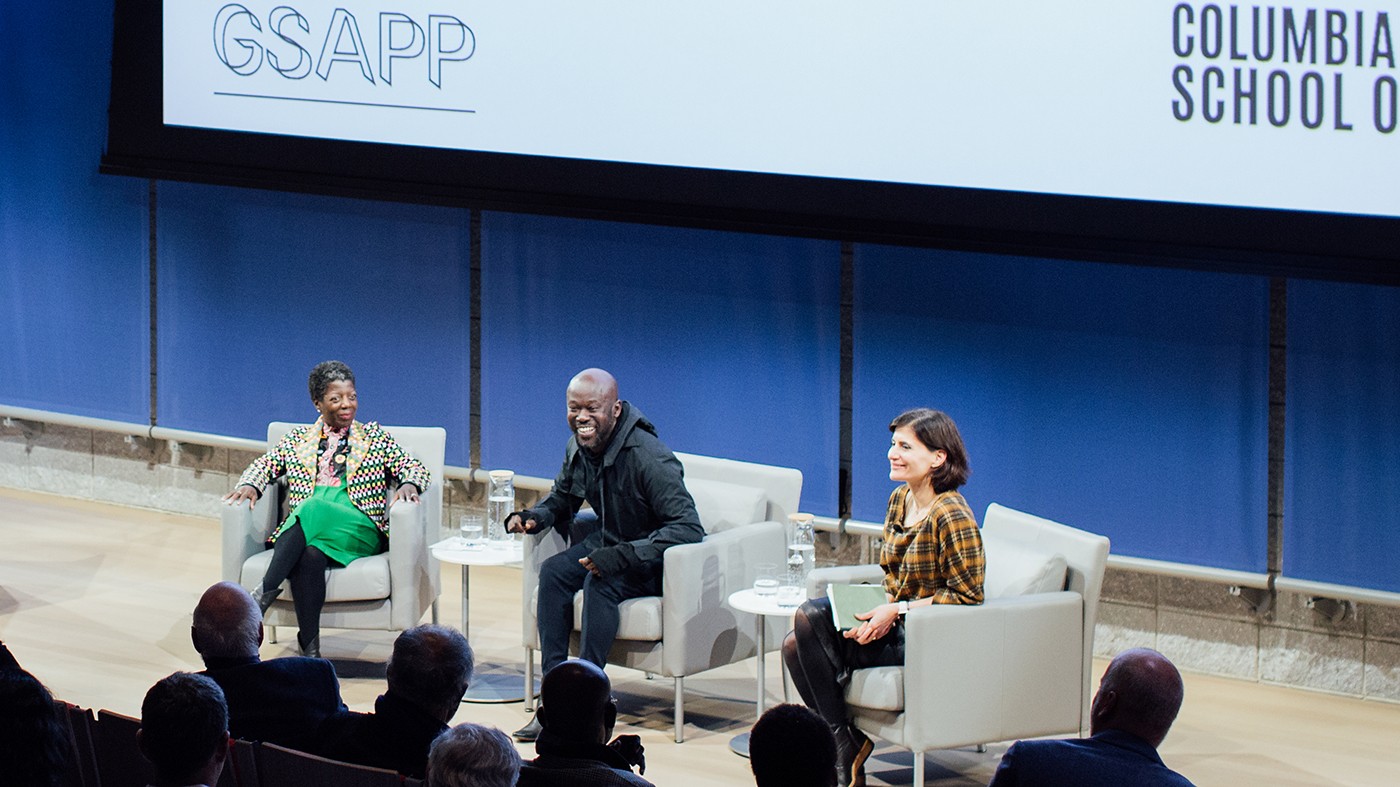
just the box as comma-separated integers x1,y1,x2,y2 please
519,660,651,787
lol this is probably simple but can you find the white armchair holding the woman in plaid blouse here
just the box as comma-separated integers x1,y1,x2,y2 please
808,503,1109,787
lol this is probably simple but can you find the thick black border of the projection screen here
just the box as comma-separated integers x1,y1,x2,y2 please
99,0,1400,284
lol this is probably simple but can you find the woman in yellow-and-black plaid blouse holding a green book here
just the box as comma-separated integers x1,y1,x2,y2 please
783,409,986,787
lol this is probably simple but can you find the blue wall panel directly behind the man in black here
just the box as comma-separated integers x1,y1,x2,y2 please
482,213,840,513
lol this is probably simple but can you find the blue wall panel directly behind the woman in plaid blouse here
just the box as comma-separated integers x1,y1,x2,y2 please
853,245,1268,571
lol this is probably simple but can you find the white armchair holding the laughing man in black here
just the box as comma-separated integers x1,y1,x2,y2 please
521,454,802,744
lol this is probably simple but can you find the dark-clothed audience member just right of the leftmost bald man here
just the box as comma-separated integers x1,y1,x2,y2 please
318,626,473,779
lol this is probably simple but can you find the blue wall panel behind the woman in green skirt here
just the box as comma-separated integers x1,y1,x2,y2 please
157,183,470,465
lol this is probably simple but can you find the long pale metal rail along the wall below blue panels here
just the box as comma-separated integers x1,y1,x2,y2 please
0,405,1400,606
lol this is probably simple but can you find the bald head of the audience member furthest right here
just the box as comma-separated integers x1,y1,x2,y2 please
1089,648,1184,746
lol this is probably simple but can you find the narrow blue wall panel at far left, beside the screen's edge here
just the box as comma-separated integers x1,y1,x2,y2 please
0,0,150,423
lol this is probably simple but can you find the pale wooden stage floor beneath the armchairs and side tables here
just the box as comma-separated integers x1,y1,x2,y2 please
0,489,1400,787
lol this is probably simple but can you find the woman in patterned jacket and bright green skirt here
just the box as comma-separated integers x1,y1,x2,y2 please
224,361,430,657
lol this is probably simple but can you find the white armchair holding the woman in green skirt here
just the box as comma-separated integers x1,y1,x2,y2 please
221,422,447,641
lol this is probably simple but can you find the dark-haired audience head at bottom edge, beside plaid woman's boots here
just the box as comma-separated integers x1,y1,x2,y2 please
749,703,836,787
